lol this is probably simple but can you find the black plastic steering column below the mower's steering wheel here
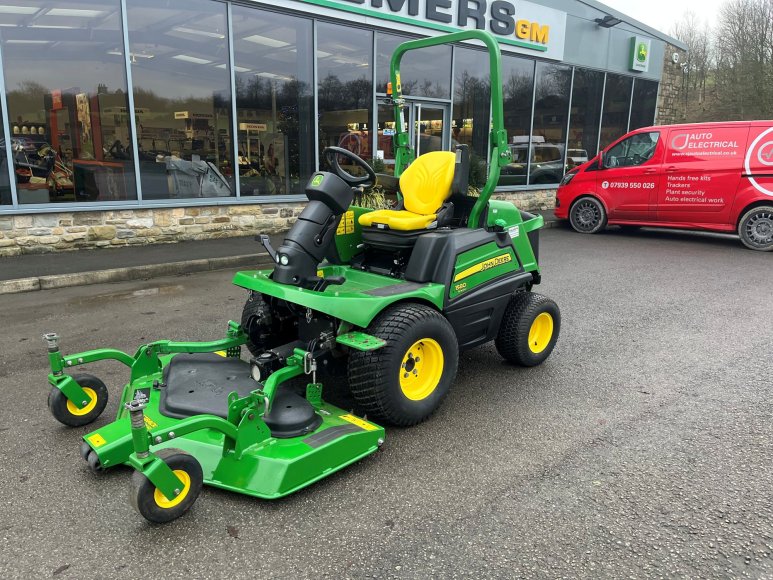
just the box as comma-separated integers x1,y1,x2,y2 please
273,171,354,287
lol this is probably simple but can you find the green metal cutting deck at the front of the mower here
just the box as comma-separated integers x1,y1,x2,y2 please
84,355,384,499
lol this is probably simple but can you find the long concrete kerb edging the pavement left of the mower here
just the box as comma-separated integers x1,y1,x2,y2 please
0,254,271,294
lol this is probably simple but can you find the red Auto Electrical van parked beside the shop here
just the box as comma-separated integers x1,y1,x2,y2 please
555,121,773,251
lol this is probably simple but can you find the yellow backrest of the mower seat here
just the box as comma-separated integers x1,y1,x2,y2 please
400,151,456,215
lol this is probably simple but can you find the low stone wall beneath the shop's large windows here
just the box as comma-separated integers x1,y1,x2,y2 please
0,190,555,257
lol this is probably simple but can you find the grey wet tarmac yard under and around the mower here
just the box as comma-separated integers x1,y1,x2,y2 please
0,224,773,579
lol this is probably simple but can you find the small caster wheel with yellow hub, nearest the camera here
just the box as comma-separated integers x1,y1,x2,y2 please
129,448,204,524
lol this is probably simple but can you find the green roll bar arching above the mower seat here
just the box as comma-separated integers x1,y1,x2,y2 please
390,30,512,228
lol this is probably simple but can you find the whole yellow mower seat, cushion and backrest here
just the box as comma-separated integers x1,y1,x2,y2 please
359,151,456,231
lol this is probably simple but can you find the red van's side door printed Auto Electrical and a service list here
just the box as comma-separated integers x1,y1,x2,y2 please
657,124,749,224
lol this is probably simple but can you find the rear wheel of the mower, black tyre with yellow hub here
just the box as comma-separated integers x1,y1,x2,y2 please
494,292,561,367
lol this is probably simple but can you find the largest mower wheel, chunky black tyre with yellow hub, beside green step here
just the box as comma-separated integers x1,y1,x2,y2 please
348,304,459,427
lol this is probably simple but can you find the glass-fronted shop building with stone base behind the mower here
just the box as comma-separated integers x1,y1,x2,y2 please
0,0,684,255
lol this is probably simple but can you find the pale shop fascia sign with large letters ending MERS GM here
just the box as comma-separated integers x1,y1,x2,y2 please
290,0,566,60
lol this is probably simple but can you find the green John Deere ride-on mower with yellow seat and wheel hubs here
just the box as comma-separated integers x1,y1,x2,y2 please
45,31,560,522
